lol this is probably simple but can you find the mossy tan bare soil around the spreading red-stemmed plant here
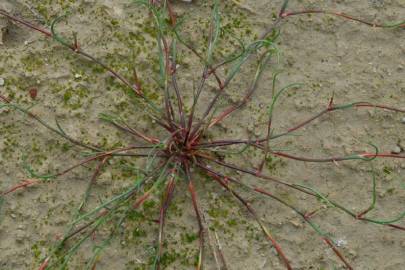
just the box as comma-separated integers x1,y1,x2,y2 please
0,0,405,270
